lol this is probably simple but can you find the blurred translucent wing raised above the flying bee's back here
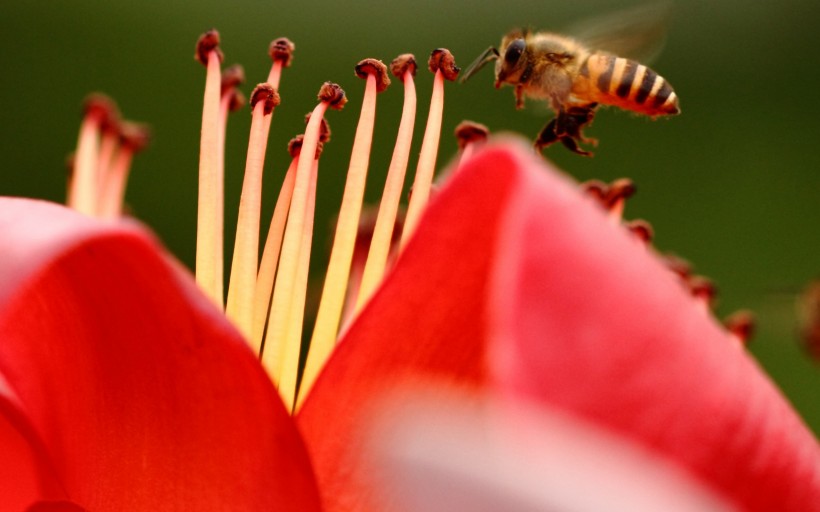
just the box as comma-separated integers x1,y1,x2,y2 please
566,1,672,64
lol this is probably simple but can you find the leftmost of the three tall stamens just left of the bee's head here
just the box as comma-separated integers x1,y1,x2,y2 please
303,59,390,404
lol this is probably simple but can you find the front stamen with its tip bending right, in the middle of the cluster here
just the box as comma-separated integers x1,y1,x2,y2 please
262,82,347,394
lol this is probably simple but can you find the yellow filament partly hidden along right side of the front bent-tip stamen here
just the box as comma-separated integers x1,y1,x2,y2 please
279,159,319,412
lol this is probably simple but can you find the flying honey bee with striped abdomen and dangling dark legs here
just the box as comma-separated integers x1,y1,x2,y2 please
462,6,680,156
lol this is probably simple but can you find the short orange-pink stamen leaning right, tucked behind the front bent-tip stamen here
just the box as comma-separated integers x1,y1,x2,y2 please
251,135,304,355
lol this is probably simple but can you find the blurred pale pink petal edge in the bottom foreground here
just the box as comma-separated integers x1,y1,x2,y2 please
367,393,734,512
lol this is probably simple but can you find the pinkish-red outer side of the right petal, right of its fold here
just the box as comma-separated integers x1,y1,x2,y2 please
484,146,820,511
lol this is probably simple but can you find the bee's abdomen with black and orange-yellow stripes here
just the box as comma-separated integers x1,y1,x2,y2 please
572,53,680,116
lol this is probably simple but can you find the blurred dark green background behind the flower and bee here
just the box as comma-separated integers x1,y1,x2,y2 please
0,0,820,433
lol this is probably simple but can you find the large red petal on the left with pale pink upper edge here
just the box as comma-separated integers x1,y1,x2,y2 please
0,199,318,511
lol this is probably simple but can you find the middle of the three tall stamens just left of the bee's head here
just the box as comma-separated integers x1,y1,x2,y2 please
356,53,417,311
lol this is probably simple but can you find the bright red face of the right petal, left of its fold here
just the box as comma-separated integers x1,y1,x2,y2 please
297,147,524,511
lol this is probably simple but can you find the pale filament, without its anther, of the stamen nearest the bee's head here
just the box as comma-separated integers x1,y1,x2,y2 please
401,70,444,247
